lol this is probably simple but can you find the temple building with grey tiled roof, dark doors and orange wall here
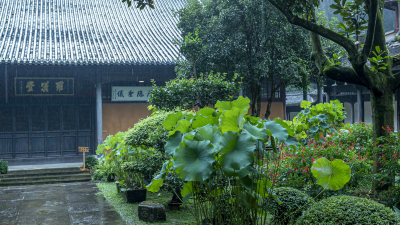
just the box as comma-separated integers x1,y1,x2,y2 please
0,0,185,163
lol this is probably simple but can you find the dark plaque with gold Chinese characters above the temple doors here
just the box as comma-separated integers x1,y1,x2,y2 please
14,77,74,96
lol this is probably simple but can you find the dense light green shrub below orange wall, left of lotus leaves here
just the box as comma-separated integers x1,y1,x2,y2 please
125,111,172,152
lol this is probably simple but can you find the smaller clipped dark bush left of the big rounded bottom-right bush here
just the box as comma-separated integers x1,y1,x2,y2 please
266,187,314,224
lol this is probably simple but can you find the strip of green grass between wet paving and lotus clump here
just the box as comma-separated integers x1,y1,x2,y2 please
97,183,196,225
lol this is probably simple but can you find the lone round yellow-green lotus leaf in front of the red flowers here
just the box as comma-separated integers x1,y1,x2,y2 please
311,157,351,191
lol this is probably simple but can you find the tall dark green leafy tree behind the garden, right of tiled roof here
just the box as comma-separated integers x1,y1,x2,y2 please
176,0,311,115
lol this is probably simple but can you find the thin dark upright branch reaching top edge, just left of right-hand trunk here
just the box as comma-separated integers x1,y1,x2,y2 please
362,0,378,61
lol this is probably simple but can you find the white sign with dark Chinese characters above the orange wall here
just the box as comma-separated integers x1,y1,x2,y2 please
111,86,153,102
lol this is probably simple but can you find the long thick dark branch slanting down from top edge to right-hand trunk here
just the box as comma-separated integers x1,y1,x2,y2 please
268,0,358,59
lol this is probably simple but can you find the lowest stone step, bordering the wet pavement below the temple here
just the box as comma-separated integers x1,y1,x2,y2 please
0,175,91,187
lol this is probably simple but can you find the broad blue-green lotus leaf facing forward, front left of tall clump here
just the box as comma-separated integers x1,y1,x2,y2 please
174,139,215,181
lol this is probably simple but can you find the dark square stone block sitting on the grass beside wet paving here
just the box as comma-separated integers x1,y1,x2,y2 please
138,201,167,222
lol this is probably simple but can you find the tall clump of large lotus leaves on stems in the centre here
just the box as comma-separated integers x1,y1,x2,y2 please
147,97,289,224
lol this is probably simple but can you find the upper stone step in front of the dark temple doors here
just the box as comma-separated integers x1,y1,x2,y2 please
0,167,81,179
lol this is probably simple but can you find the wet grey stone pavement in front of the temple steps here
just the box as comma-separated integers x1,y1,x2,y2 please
0,182,125,225
